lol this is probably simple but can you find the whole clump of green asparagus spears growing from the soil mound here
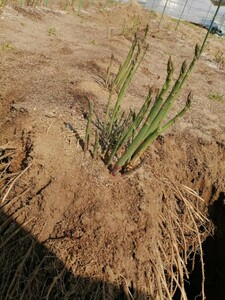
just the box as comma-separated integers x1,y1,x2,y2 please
84,7,221,175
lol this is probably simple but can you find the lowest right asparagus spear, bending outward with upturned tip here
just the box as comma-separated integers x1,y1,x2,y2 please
131,93,192,165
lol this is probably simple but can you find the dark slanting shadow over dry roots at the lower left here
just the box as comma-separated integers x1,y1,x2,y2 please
0,213,146,300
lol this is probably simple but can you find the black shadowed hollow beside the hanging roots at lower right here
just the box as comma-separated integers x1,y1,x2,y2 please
187,192,225,300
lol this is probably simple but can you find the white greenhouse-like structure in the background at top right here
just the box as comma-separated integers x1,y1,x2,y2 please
145,0,225,26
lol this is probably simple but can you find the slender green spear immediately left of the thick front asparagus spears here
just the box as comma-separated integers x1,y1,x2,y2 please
107,89,152,166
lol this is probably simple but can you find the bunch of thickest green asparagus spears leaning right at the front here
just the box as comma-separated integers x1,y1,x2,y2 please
112,45,199,175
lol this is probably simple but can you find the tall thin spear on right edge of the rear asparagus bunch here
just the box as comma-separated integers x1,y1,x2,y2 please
108,45,148,135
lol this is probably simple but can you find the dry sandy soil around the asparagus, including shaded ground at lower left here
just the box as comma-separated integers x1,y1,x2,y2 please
0,1,225,299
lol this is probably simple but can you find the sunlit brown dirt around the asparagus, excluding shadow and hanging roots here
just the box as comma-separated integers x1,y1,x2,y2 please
0,3,225,299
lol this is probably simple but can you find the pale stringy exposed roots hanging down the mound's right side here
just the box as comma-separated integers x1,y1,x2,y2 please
149,180,212,300
